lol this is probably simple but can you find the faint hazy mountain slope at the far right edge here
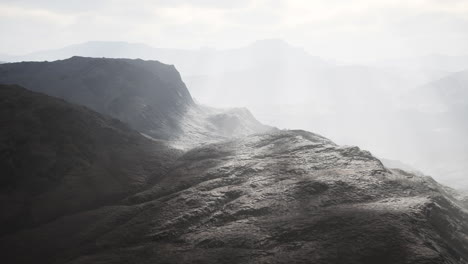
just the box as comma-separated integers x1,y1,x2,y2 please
394,71,468,187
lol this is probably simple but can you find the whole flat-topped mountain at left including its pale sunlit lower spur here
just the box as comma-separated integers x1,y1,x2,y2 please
0,57,270,144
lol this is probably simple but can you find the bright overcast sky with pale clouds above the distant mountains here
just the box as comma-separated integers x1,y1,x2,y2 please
0,0,468,61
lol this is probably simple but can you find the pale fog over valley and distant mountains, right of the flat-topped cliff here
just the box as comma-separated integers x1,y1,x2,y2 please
178,40,468,188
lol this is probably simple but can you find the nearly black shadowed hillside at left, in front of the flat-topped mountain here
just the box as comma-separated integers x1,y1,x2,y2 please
0,85,179,234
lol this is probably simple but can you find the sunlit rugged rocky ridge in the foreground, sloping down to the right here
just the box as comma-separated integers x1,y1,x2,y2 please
0,127,468,264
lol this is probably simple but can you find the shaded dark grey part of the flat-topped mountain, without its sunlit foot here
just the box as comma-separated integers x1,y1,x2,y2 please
0,57,193,138
